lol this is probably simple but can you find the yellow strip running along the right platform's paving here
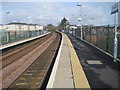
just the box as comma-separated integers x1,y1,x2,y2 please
65,35,91,90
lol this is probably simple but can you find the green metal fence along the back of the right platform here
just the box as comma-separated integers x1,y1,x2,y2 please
74,25,120,58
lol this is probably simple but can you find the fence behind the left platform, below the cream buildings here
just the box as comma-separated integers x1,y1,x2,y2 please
0,30,45,45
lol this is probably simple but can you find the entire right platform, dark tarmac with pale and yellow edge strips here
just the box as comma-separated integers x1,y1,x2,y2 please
47,33,120,90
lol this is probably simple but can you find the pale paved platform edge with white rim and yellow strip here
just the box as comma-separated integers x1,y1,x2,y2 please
47,33,90,89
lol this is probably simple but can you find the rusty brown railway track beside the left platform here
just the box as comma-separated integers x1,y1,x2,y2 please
2,34,52,68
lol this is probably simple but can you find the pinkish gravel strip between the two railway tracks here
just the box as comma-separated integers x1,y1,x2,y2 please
0,34,56,88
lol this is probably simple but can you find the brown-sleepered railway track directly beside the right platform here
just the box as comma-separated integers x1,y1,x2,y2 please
9,34,60,88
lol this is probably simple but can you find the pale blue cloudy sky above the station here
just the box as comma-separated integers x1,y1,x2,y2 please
2,2,114,25
